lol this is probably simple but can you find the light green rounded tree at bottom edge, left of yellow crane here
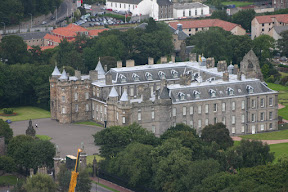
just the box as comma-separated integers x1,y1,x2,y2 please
23,174,57,192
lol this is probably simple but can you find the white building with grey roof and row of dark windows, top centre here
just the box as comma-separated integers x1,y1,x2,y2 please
173,2,209,19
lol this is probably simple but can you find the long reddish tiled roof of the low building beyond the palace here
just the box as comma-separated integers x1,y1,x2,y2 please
169,19,242,31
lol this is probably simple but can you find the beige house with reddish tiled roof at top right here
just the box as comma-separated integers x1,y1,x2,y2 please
251,14,288,39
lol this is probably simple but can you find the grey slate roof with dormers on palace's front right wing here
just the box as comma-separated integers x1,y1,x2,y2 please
168,80,275,103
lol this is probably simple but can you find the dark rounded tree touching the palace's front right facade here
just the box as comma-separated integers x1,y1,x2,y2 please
201,123,234,149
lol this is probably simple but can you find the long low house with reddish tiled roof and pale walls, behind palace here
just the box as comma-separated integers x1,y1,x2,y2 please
169,19,246,36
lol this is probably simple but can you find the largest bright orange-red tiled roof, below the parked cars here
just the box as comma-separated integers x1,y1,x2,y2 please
52,23,88,37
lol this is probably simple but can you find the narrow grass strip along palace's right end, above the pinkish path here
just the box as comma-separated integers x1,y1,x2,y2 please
240,130,288,140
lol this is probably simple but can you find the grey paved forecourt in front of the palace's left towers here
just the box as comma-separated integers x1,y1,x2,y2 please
10,118,103,158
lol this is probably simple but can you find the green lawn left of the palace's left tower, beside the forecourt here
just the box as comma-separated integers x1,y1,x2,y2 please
0,107,50,122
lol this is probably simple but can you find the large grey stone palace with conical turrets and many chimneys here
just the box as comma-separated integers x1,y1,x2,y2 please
50,50,278,136
